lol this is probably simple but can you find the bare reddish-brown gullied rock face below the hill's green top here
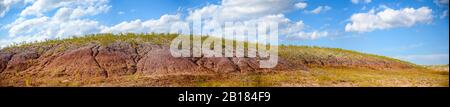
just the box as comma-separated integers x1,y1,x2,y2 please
0,42,300,78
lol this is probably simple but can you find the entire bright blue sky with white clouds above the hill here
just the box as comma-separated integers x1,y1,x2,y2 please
0,0,449,64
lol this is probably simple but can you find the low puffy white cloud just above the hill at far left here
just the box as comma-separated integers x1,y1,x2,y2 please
6,16,101,38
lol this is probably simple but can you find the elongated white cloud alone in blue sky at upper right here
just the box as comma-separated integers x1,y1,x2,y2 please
345,7,433,32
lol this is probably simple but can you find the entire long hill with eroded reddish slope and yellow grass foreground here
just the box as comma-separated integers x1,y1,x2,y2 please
0,33,448,87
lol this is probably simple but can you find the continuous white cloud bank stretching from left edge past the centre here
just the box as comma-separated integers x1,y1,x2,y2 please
0,0,331,46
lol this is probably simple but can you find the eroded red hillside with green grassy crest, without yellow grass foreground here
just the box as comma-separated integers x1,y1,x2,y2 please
0,34,442,86
